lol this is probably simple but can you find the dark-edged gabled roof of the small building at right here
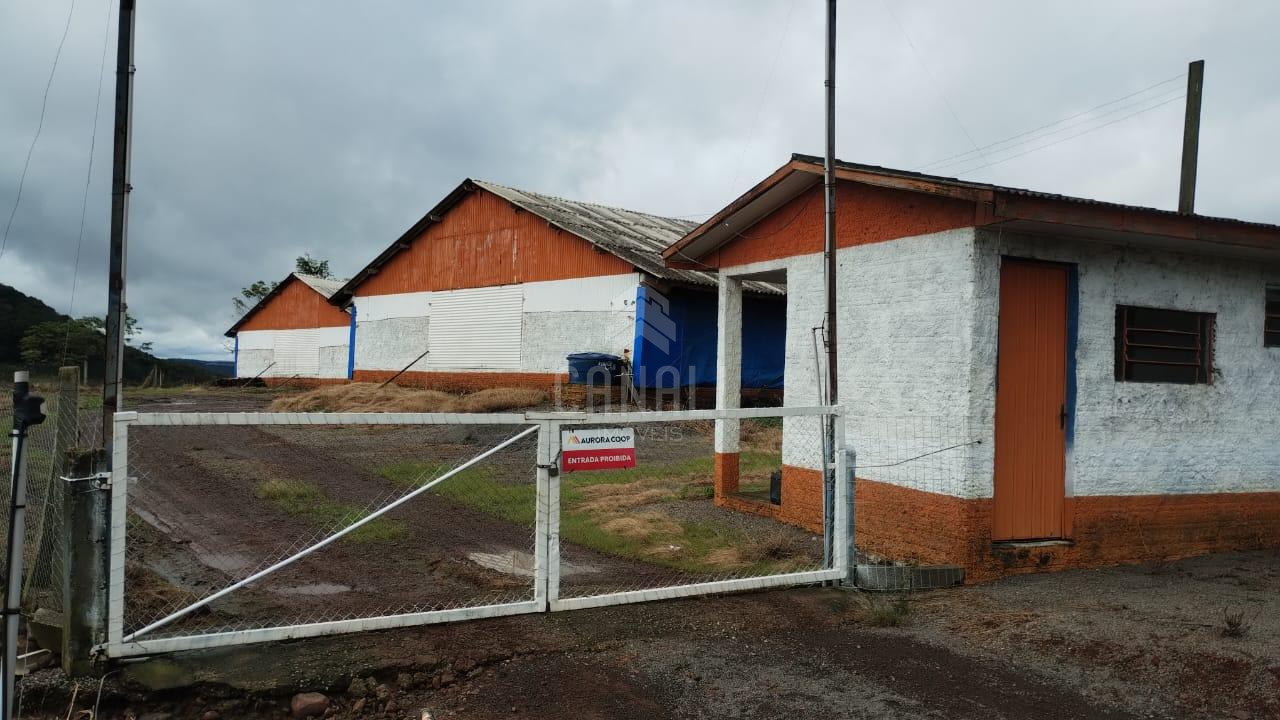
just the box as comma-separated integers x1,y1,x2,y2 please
663,154,1280,266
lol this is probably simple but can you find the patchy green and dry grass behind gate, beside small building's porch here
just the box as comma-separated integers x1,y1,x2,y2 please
378,452,810,574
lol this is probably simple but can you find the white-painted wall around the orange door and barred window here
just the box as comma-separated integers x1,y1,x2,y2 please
972,231,1280,496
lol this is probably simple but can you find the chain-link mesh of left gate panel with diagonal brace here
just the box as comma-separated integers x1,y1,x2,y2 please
112,414,538,650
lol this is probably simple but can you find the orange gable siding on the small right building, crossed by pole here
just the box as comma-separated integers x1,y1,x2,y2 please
704,182,975,268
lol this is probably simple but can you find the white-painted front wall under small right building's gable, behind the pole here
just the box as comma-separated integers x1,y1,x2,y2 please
722,228,972,481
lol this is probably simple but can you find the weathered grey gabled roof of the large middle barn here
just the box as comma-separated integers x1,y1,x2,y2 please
332,178,780,305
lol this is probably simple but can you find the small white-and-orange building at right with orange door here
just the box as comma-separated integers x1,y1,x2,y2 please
666,155,1280,579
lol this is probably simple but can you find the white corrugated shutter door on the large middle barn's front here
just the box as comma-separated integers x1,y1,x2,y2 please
426,286,525,370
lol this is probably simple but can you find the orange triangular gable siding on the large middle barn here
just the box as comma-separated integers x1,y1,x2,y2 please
356,190,634,295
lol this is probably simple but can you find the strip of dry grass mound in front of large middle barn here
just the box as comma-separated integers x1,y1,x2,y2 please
269,383,547,413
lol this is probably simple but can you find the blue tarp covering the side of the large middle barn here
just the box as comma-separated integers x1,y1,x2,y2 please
632,286,787,388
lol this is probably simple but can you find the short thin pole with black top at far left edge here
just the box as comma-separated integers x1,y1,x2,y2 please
0,370,45,720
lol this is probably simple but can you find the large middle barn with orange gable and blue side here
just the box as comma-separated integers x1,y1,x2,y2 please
332,179,785,391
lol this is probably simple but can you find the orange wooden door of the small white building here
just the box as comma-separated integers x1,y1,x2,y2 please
992,258,1069,541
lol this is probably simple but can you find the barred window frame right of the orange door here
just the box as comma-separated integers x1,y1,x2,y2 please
1114,302,1217,386
